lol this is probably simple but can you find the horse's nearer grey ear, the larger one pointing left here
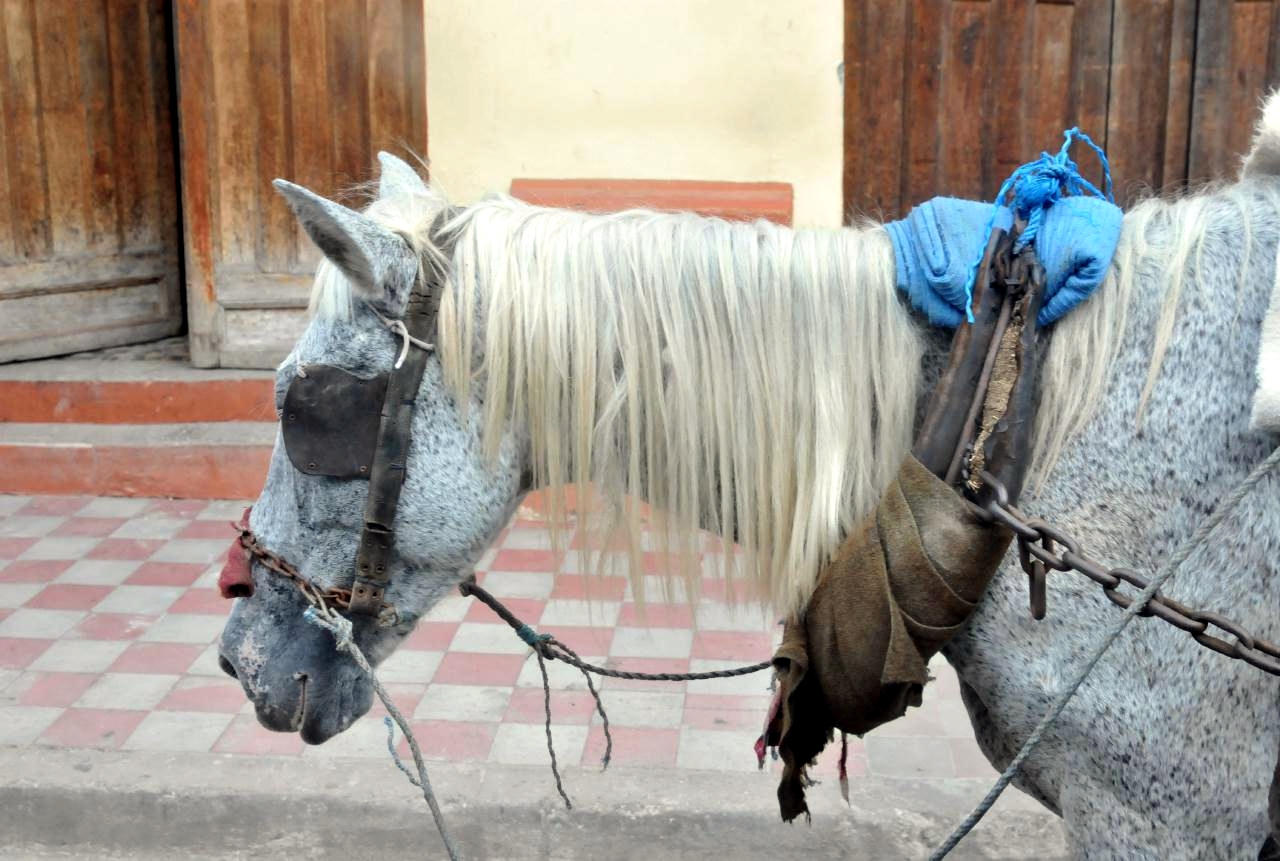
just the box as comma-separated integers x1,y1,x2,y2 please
271,177,417,317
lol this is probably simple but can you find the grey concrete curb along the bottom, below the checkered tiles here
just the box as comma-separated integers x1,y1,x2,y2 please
0,748,1068,861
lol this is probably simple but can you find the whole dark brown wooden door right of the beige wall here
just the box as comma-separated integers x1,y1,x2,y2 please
844,0,1280,219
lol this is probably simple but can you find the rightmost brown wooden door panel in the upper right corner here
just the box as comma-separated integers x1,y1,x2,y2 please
1188,0,1280,182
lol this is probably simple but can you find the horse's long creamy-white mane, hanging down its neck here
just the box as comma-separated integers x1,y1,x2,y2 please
312,177,1276,614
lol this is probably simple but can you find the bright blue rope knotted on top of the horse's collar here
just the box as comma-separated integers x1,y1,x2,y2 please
964,127,1115,322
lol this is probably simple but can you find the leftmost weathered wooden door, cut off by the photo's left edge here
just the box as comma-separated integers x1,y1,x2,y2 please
0,0,182,361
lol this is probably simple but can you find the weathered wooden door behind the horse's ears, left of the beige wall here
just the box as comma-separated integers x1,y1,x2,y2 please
175,0,426,367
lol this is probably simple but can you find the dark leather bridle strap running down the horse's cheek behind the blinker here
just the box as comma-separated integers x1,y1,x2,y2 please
349,252,444,615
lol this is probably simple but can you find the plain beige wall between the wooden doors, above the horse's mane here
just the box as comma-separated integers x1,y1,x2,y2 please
426,0,842,226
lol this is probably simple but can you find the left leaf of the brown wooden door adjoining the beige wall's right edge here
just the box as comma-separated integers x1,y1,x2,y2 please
844,0,1112,217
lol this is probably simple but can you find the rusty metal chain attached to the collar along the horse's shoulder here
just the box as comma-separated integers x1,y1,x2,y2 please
982,472,1280,675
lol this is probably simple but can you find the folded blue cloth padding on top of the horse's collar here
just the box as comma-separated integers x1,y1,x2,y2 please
884,196,1123,329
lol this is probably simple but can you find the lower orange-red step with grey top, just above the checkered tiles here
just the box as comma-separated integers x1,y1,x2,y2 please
0,421,275,499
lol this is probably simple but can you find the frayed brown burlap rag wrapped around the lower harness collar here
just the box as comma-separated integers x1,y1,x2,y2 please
765,457,1011,821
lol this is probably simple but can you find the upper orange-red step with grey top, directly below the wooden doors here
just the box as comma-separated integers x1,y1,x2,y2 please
0,359,275,425
